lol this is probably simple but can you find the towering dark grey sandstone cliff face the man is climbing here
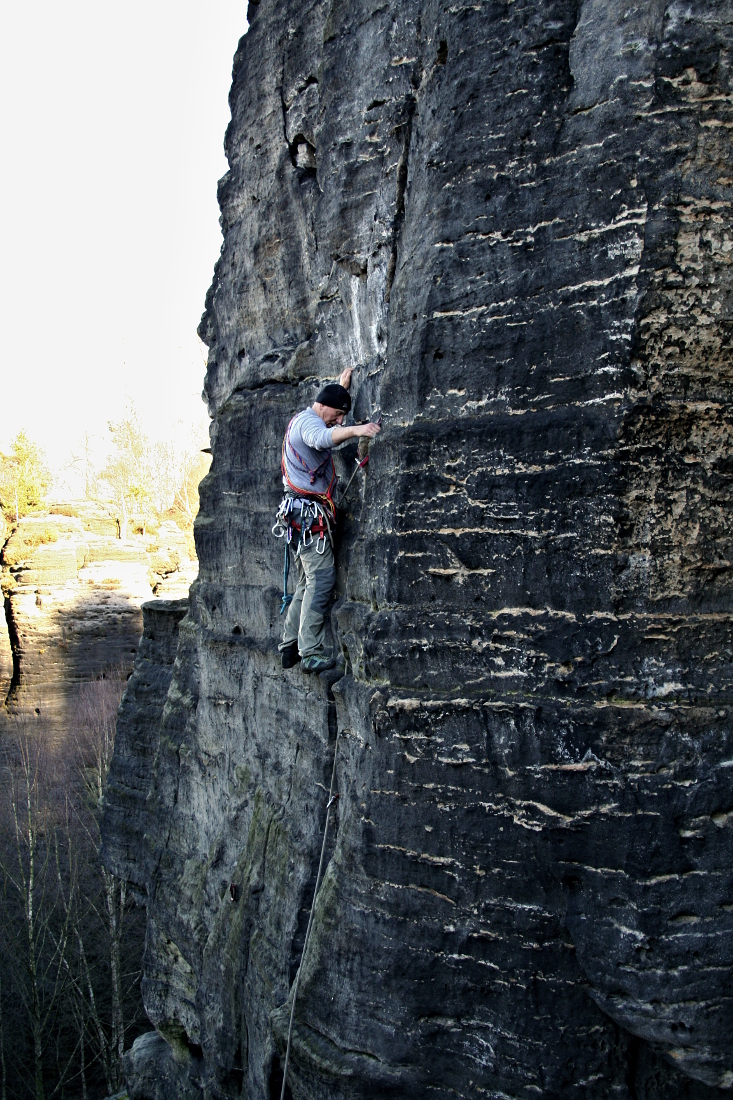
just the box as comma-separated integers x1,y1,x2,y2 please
102,0,733,1100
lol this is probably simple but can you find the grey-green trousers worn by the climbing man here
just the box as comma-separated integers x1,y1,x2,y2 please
278,539,336,657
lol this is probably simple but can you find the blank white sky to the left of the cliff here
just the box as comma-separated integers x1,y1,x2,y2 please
0,0,247,475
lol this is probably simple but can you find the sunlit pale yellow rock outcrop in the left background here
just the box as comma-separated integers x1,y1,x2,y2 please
0,503,197,735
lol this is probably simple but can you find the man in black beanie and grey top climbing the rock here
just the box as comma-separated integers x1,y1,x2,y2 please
273,367,380,672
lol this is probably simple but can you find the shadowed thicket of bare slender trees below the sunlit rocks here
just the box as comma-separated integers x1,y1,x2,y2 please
0,674,144,1100
